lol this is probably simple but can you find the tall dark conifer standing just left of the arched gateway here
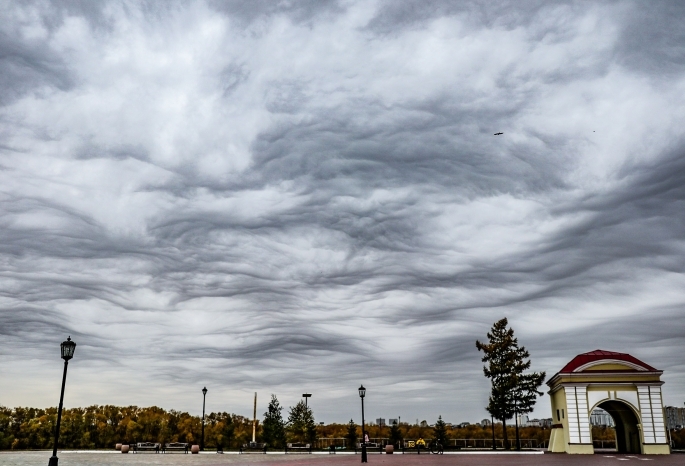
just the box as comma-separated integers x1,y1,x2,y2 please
476,318,545,450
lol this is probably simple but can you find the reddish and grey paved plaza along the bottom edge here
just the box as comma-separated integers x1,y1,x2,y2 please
0,451,685,466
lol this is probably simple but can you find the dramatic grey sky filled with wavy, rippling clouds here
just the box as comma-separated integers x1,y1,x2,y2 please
0,0,685,422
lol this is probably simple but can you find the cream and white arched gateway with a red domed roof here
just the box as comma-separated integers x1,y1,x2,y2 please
547,350,671,454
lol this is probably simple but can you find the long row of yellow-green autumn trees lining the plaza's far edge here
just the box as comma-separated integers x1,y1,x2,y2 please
0,404,685,450
